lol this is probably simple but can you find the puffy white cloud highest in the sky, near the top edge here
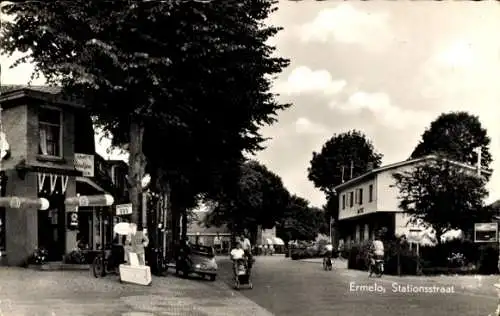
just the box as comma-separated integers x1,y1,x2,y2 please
300,3,392,50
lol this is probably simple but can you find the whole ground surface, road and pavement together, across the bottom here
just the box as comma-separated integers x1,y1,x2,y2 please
0,256,498,316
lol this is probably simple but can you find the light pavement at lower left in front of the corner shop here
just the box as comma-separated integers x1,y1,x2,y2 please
0,267,272,316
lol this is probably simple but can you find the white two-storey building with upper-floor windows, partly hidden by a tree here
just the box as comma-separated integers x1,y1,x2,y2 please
335,156,491,245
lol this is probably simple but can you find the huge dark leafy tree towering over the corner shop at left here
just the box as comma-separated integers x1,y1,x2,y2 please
0,0,288,230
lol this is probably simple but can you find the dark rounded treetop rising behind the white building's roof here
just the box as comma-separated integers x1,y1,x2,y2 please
411,112,493,168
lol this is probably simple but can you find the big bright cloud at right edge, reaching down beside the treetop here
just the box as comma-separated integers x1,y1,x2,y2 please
418,37,500,202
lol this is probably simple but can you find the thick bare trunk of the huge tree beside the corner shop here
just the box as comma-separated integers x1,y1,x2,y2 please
128,121,146,229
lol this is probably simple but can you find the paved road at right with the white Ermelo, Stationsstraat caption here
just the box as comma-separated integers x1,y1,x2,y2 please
219,256,497,316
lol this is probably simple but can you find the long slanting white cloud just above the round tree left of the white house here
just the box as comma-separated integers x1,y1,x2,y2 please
328,91,427,129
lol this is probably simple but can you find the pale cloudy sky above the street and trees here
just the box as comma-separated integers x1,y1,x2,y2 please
0,0,500,206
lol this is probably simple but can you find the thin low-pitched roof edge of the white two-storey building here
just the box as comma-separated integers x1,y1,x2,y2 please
334,155,492,191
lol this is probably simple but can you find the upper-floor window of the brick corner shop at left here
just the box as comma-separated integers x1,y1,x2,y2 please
38,108,62,157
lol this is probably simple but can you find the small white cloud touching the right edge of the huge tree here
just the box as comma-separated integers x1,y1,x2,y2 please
274,66,347,95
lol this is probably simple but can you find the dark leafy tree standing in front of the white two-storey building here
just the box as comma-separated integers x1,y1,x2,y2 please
393,158,488,242
